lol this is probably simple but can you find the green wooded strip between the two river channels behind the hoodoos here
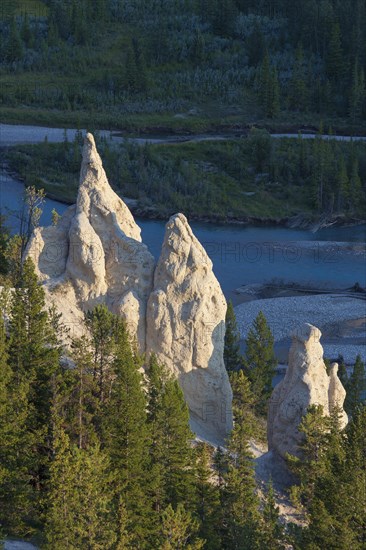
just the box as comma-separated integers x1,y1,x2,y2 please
5,130,366,222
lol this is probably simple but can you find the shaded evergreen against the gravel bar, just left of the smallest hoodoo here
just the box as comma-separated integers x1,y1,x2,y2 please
245,311,277,414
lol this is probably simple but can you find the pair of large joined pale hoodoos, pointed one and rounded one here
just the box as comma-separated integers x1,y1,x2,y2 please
27,134,232,442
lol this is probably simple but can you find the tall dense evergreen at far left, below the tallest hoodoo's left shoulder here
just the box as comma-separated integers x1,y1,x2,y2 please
9,258,61,514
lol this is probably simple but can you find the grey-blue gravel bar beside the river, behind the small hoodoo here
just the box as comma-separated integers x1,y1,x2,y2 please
235,294,366,364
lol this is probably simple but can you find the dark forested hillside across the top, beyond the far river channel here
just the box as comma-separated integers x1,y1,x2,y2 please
0,0,366,133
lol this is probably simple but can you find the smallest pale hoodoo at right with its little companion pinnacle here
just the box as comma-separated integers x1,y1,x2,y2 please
268,323,348,458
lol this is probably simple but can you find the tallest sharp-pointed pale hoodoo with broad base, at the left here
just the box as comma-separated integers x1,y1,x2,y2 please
27,134,154,351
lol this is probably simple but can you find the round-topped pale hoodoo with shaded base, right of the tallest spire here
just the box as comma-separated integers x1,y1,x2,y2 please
146,214,232,446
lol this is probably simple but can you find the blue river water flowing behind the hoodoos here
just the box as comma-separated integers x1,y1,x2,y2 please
0,125,366,303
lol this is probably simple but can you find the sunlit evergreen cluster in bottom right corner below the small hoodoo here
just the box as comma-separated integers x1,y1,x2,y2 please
289,405,366,550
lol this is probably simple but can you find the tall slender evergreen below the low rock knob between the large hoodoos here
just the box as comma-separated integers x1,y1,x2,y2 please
101,322,151,547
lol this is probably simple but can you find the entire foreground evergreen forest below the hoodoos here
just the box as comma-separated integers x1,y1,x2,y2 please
0,259,366,550
